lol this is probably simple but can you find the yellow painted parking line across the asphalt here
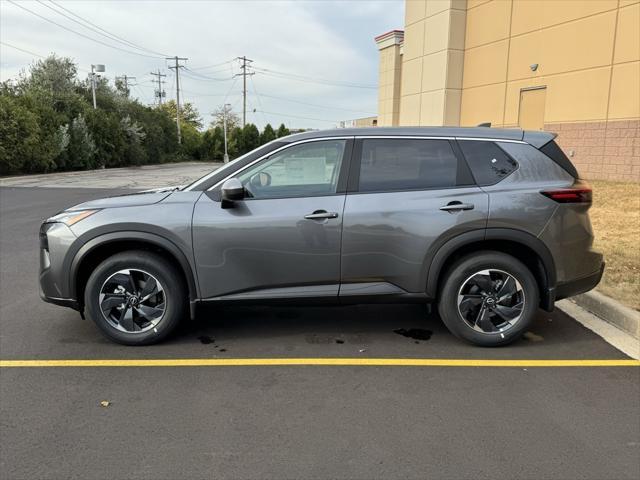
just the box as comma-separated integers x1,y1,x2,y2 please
0,358,640,368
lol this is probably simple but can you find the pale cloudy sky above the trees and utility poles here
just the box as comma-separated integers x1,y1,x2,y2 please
0,0,404,128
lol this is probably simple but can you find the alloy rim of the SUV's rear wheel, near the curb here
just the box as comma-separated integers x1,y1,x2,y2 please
458,269,525,334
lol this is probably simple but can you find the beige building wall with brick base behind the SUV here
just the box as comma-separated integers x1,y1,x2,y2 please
381,0,640,180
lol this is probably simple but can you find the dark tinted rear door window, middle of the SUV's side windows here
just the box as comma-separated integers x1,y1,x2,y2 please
359,139,458,192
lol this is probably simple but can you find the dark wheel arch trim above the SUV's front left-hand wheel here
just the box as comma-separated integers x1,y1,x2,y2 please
68,231,198,308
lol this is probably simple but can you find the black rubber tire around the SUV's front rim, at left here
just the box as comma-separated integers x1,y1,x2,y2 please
84,250,187,345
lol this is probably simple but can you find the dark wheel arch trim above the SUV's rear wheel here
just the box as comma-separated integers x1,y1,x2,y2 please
427,228,556,311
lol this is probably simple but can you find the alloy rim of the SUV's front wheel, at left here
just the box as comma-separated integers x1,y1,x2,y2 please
98,268,166,333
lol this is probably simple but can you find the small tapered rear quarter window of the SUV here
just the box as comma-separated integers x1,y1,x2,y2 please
458,140,518,185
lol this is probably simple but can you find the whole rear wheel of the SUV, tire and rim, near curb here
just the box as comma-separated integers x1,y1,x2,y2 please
438,251,539,347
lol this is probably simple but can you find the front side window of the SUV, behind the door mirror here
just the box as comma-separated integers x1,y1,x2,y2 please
238,140,346,199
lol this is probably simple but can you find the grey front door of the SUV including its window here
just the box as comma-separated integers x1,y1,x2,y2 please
193,139,351,299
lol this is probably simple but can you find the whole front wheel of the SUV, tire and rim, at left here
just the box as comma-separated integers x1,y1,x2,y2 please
85,251,186,345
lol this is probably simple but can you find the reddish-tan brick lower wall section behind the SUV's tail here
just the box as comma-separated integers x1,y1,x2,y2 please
545,120,640,182
